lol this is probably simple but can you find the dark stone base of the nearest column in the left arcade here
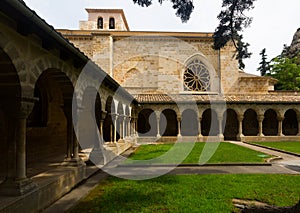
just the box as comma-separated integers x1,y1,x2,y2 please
0,178,38,196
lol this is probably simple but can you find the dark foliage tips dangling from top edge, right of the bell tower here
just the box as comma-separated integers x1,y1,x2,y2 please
133,0,194,22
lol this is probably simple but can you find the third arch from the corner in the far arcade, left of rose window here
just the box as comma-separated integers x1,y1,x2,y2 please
181,109,199,136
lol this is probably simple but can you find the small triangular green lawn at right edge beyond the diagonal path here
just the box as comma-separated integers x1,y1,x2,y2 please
253,141,300,154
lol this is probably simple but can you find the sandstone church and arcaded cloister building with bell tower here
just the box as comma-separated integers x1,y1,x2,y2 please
0,0,300,212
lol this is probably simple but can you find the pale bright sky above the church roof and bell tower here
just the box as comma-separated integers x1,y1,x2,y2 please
24,0,300,75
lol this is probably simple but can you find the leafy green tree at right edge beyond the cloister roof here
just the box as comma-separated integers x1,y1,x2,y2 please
268,57,300,90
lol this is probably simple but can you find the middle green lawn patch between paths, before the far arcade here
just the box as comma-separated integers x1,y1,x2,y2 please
126,142,270,163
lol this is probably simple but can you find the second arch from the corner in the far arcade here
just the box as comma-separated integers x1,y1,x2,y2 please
159,109,178,136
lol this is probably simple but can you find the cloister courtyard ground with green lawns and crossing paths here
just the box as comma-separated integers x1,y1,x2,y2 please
41,142,300,212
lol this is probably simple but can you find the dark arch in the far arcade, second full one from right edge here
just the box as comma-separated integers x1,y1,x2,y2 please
263,109,278,136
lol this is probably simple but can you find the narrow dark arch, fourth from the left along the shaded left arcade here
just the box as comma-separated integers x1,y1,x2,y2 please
103,96,115,142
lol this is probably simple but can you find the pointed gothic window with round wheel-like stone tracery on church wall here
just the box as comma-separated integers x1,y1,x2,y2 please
183,58,210,92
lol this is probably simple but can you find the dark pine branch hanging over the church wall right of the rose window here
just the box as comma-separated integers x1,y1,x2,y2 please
214,0,255,69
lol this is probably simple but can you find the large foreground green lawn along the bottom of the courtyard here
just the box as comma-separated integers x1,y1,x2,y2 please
71,174,300,213
